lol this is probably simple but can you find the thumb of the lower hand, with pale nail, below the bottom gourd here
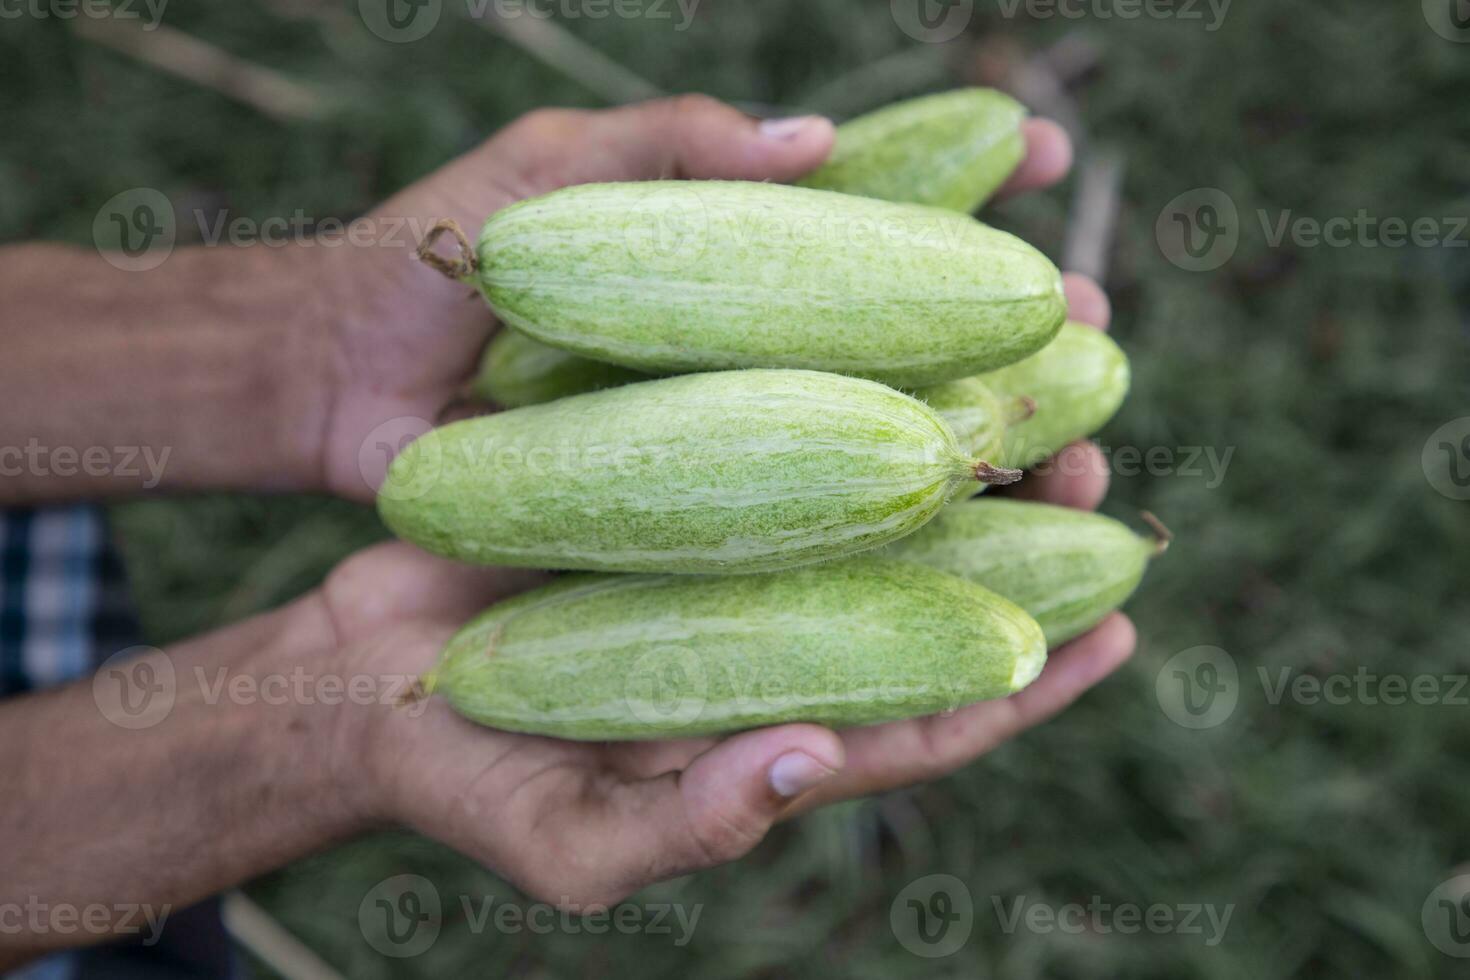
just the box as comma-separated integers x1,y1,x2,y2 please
581,724,844,895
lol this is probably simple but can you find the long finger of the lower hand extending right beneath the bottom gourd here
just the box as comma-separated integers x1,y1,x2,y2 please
792,613,1136,811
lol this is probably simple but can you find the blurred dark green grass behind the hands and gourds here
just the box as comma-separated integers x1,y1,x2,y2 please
0,0,1470,980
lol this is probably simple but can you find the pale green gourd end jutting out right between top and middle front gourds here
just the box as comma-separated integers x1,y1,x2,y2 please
980,323,1130,469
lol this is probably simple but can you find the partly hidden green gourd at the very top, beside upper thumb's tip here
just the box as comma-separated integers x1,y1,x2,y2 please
801,88,1026,215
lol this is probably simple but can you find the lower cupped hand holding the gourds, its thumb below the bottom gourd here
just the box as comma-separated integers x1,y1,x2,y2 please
323,278,1135,907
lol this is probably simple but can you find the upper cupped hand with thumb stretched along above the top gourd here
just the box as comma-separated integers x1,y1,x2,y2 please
304,96,1072,500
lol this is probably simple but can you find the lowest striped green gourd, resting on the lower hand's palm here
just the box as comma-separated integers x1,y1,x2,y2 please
426,555,1045,739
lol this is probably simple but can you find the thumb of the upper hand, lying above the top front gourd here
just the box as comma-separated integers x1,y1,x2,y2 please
598,96,833,181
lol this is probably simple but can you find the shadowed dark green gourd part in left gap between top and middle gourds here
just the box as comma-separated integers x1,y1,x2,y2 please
470,328,648,408
